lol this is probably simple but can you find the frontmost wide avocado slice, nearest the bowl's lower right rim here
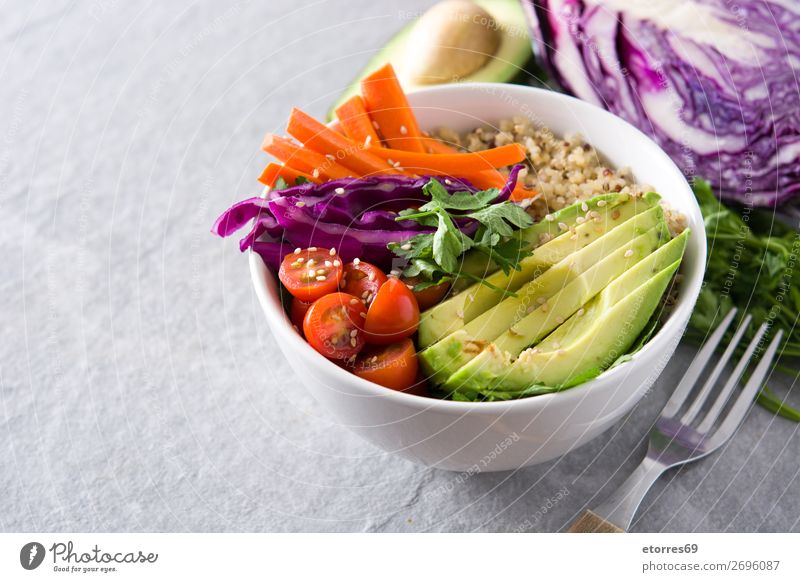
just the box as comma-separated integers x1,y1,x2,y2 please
447,229,689,400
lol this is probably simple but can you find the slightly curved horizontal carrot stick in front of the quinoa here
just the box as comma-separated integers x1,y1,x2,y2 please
369,143,525,176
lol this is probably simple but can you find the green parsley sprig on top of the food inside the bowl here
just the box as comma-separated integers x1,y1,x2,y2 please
389,178,533,294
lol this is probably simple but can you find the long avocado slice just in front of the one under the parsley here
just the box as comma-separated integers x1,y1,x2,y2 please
420,206,664,383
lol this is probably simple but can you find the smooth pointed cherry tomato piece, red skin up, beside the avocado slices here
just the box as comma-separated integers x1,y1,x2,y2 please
364,277,419,345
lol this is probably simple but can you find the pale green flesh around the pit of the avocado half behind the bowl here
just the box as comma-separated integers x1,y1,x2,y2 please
327,0,533,121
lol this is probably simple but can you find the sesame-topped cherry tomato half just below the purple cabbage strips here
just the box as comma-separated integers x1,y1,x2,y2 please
278,247,343,301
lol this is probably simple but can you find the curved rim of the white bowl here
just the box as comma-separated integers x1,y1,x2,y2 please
248,82,707,413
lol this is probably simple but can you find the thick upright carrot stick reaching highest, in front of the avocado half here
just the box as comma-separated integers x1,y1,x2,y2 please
361,63,425,153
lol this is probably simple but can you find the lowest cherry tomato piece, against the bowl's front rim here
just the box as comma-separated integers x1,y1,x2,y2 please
353,338,418,391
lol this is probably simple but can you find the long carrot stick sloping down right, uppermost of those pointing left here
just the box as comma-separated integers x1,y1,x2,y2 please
286,107,398,176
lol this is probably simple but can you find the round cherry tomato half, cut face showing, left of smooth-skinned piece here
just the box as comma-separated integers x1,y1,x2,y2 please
303,293,366,360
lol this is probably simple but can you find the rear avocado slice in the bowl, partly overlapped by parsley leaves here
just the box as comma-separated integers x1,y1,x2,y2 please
419,193,660,348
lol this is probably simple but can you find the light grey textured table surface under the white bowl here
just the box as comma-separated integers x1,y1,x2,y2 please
0,0,800,532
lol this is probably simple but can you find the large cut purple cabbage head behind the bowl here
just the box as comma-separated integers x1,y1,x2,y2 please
523,0,800,206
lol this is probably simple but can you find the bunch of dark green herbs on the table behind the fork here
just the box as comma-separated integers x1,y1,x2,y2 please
687,180,800,422
